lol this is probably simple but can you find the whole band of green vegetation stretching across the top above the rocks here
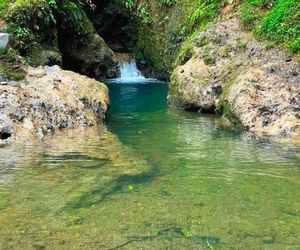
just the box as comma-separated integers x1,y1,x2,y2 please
0,0,300,75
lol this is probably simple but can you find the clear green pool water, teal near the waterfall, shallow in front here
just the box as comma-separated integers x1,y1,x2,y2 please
0,83,300,249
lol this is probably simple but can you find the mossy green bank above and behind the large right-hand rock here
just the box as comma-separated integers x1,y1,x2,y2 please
132,0,300,77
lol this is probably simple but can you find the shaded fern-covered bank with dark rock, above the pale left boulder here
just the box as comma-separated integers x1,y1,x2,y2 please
0,0,117,77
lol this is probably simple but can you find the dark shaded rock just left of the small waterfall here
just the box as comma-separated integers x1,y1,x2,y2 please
62,34,119,79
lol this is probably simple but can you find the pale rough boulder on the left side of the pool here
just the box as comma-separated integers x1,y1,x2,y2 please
0,66,109,143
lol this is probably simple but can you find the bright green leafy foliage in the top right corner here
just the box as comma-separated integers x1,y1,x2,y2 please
241,0,300,53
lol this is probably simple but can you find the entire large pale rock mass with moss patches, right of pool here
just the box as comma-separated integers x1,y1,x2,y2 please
169,19,300,136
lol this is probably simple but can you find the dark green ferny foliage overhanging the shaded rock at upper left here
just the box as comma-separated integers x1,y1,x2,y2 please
4,0,93,55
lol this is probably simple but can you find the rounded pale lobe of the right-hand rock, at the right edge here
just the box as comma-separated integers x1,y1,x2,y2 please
226,67,300,135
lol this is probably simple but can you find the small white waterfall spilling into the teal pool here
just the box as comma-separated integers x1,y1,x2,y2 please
109,59,157,83
